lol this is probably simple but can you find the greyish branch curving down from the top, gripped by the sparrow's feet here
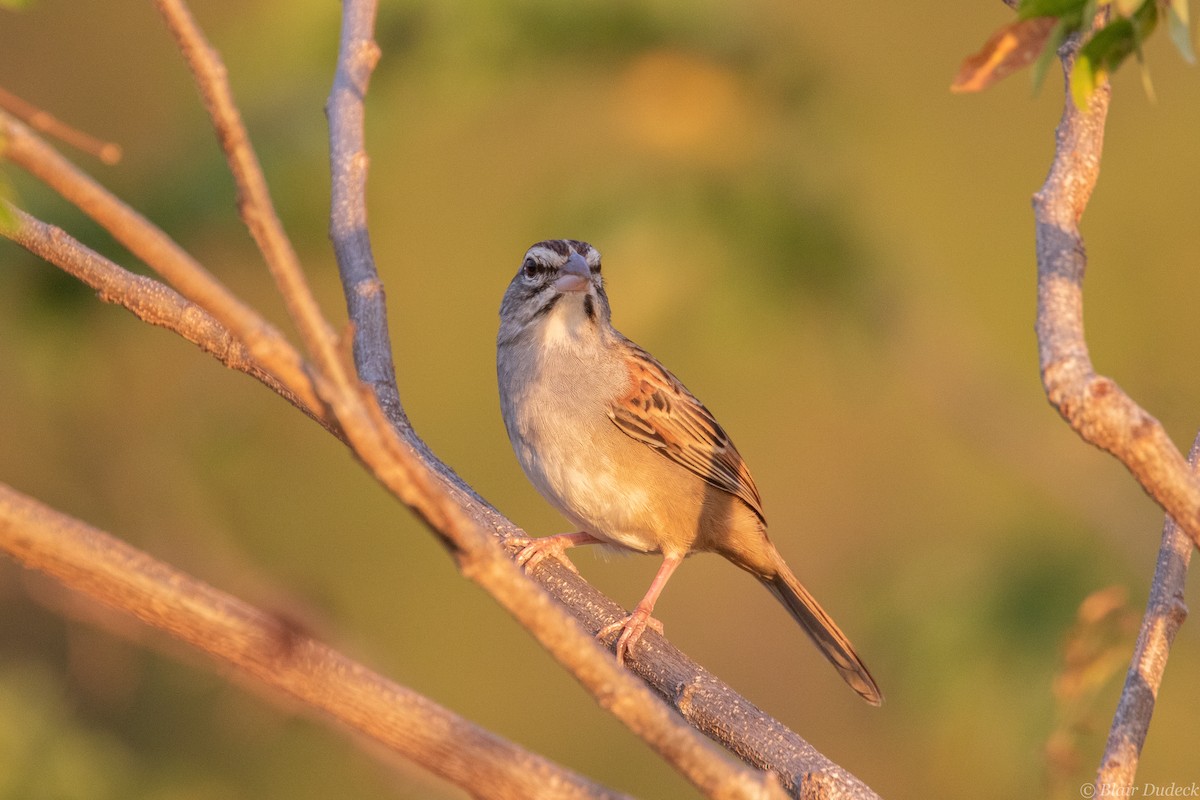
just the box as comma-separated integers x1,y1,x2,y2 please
325,0,874,796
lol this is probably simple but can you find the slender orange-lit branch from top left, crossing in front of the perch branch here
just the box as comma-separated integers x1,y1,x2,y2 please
150,0,796,798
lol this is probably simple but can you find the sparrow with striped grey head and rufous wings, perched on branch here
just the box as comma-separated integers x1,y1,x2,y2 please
496,239,883,705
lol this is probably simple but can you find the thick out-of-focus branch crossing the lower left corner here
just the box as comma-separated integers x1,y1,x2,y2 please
0,483,624,800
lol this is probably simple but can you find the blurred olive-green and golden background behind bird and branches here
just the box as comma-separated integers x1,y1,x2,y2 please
0,0,1200,800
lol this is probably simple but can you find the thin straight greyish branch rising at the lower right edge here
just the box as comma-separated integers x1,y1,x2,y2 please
1096,434,1200,798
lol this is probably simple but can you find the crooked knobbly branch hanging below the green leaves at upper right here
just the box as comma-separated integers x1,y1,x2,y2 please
1033,26,1200,551
